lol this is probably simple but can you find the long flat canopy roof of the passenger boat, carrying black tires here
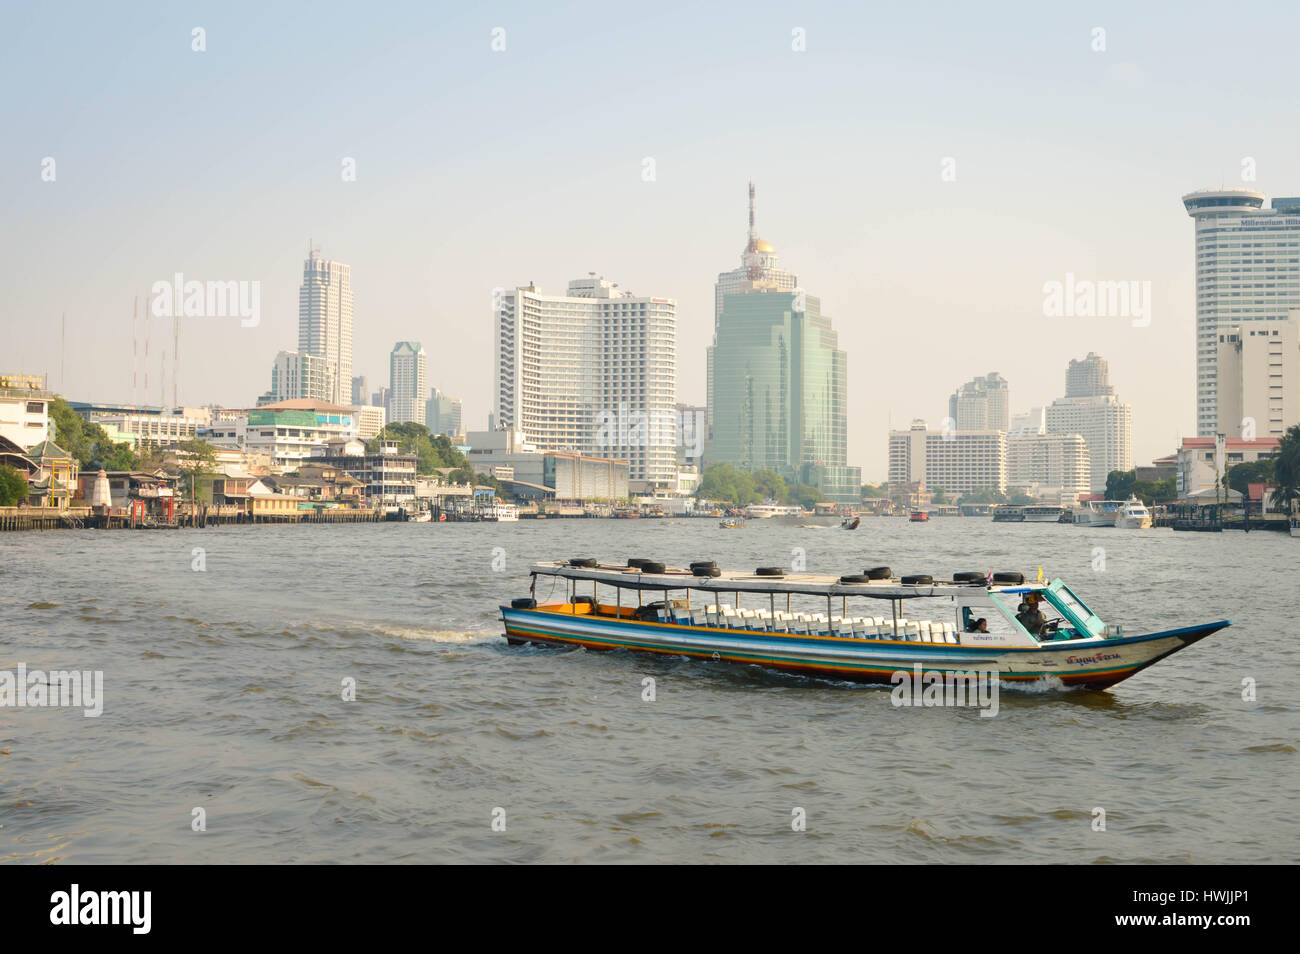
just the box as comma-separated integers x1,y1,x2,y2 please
529,561,1048,599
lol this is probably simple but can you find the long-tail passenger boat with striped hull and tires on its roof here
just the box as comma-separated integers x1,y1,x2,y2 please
501,559,1231,689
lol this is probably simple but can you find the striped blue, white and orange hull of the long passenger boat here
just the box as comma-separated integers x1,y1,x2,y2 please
501,606,1230,689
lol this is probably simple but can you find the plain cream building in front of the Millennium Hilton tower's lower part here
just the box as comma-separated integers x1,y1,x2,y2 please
1216,317,1300,438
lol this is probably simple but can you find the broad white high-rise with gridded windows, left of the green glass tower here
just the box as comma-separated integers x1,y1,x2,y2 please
493,273,677,483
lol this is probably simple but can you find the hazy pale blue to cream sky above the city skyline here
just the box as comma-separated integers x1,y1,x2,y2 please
0,1,1300,480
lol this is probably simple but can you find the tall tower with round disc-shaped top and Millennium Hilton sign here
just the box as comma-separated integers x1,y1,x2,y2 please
1185,188,1300,439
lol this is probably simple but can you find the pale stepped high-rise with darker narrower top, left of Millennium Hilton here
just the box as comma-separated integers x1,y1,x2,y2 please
1047,354,1134,494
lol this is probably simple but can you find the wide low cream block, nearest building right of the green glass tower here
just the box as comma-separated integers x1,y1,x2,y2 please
889,419,1006,496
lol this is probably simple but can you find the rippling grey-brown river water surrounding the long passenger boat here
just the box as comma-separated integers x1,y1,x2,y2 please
0,519,1300,863
